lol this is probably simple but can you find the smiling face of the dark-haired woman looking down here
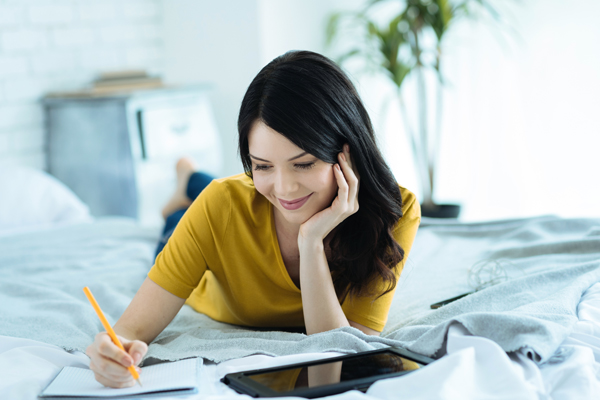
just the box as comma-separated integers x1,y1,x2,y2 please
248,121,338,225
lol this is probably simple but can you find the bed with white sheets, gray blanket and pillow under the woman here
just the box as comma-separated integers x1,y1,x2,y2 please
0,165,600,399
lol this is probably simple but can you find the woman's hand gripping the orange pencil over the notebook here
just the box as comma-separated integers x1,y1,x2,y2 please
85,332,148,388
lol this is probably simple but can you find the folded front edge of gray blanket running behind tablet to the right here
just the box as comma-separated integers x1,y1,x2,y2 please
144,263,600,362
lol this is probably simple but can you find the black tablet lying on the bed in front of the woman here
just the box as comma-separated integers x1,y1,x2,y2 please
221,347,434,398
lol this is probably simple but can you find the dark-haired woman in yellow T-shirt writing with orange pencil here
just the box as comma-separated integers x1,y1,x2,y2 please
87,51,420,387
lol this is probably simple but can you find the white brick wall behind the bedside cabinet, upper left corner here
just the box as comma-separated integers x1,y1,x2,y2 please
0,0,164,168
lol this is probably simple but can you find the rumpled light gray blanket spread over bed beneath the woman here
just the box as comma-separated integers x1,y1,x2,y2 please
0,217,600,362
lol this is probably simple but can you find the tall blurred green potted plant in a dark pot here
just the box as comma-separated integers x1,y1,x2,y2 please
327,0,508,218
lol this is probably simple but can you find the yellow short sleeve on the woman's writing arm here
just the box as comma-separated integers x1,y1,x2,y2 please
148,181,231,299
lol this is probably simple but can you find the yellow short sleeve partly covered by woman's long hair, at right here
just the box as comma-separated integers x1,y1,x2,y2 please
342,187,421,332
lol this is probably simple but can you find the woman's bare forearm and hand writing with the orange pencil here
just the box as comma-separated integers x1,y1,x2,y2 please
86,278,185,388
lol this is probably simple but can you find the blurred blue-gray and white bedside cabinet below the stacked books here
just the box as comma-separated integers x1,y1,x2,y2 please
43,86,222,226
